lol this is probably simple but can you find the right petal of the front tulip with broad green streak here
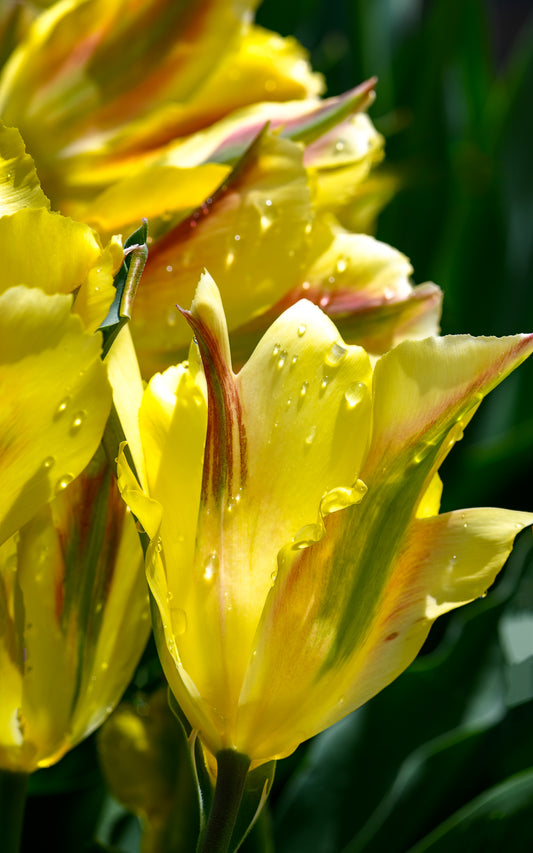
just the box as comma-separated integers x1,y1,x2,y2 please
233,336,533,757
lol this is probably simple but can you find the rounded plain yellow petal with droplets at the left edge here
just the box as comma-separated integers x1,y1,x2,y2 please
0,284,110,542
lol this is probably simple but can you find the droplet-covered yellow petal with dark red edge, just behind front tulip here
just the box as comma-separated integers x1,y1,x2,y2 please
132,133,313,372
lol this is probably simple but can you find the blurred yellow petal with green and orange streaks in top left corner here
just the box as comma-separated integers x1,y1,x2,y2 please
0,0,257,197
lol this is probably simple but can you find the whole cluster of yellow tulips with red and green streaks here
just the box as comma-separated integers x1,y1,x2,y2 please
0,0,533,850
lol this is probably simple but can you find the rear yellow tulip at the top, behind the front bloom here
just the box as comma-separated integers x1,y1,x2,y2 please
0,0,441,377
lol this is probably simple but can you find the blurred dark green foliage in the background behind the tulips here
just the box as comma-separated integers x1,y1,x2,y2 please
15,0,533,853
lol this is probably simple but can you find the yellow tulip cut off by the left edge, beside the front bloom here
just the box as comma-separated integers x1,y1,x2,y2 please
0,120,149,772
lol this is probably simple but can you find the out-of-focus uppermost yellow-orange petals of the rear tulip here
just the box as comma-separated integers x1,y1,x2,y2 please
0,0,323,210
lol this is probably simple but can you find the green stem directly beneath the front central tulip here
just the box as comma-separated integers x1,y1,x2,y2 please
200,749,250,853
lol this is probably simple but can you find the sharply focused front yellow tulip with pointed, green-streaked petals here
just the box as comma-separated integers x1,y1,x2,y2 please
119,275,533,765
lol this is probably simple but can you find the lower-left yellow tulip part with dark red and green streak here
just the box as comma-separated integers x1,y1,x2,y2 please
0,452,150,774
